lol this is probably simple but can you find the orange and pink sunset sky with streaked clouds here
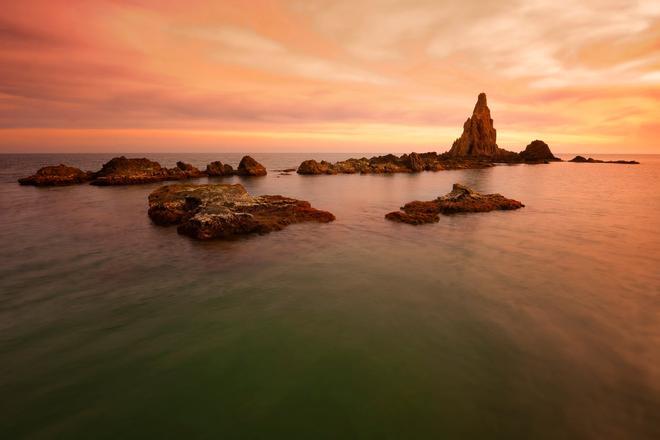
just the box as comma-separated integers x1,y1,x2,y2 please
0,0,660,153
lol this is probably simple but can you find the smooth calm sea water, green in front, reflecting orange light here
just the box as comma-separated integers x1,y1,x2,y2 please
0,153,660,439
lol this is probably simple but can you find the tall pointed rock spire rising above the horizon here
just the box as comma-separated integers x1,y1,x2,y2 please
449,93,497,157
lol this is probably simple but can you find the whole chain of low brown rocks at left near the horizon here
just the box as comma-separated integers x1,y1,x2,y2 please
18,156,268,186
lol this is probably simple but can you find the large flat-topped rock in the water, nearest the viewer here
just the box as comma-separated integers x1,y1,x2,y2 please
149,184,335,240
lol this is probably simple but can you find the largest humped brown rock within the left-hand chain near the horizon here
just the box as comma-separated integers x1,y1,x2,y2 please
91,156,204,186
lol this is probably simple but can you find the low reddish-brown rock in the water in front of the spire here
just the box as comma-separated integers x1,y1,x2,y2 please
385,183,525,225
